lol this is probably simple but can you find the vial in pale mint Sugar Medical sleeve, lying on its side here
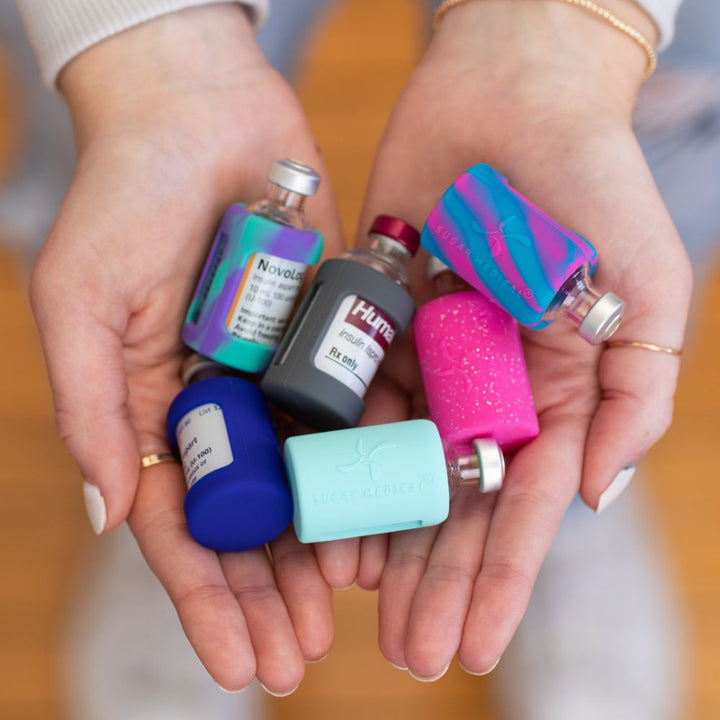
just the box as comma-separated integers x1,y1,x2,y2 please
284,420,505,543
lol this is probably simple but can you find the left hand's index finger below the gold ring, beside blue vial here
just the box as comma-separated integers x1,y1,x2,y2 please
128,464,256,691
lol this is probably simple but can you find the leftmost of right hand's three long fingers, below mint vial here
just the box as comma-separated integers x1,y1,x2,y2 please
378,526,438,668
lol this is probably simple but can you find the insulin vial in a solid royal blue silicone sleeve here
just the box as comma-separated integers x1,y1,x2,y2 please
167,355,292,551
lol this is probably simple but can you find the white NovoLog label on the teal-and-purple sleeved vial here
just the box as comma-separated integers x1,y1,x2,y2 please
225,253,307,347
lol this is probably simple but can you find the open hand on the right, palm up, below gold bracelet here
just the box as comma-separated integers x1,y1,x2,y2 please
359,0,692,679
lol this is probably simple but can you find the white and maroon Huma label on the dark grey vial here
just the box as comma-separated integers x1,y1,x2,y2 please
314,295,396,397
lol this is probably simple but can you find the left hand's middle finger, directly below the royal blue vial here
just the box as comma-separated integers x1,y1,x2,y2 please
220,547,305,696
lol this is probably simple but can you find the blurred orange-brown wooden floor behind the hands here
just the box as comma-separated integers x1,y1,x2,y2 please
0,0,720,720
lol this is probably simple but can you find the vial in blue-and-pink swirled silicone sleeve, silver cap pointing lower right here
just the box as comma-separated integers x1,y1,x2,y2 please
421,164,625,345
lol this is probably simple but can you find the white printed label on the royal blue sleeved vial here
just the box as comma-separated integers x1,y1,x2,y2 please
175,403,233,490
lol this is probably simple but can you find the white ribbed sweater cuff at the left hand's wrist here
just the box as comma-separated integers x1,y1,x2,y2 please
15,0,270,88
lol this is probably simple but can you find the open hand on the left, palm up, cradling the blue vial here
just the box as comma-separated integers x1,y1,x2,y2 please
31,3,350,693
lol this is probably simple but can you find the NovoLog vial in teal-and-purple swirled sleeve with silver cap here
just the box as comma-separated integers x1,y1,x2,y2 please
182,160,323,372
